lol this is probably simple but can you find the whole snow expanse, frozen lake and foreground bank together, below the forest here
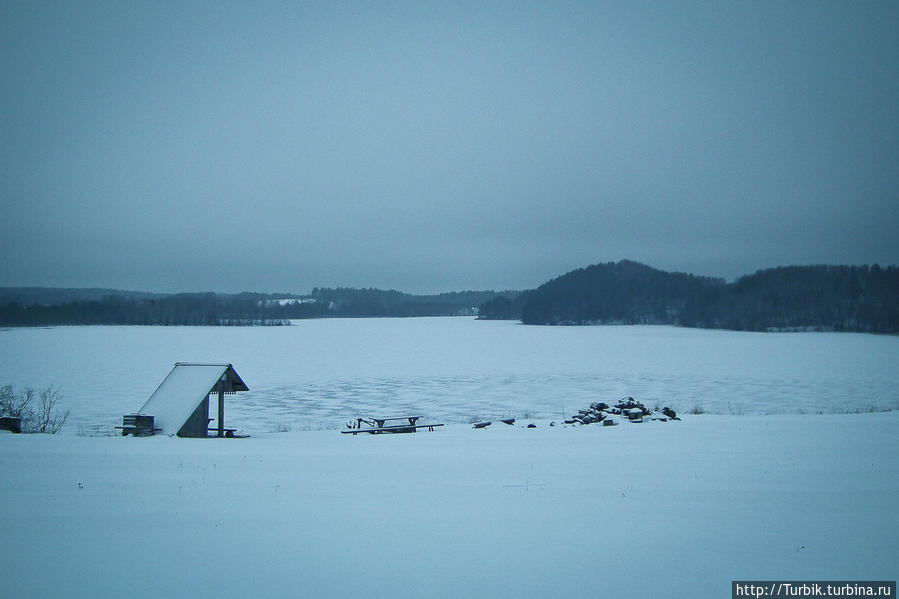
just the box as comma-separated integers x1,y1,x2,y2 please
0,318,899,598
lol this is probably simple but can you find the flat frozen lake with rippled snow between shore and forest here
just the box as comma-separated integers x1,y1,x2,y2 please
0,318,899,434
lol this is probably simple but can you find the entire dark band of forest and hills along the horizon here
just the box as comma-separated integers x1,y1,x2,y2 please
0,260,899,333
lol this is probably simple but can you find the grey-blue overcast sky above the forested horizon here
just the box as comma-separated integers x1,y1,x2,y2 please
0,0,899,293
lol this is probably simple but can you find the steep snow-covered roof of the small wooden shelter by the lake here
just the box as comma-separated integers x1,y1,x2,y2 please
138,362,249,435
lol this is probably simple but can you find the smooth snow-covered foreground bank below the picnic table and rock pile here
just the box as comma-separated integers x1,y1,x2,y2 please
0,412,899,598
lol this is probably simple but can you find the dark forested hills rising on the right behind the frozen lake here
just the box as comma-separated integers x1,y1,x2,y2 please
480,260,899,333
